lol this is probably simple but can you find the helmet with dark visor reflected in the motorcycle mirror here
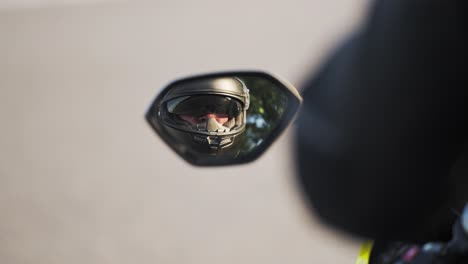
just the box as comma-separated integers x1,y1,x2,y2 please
159,77,250,149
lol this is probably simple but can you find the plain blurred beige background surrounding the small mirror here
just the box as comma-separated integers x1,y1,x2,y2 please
0,0,368,264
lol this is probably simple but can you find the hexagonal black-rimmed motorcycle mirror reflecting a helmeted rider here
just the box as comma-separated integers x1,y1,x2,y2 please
146,72,302,166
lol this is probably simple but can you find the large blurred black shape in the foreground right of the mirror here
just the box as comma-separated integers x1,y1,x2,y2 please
296,0,468,240
